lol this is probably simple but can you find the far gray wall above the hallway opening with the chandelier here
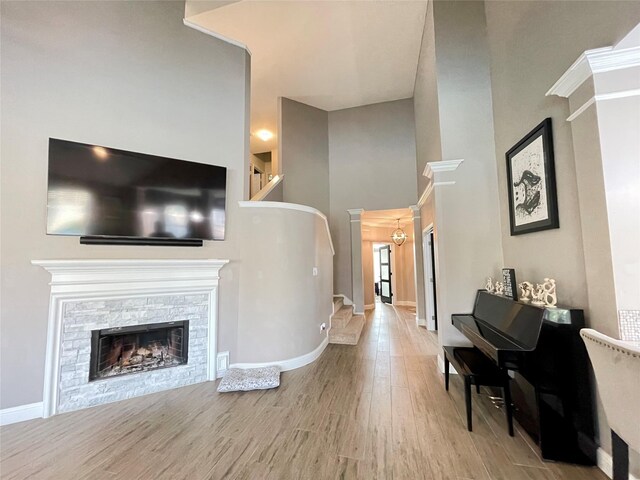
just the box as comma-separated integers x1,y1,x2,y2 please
330,99,417,298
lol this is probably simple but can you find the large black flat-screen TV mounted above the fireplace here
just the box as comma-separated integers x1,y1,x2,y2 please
47,138,227,240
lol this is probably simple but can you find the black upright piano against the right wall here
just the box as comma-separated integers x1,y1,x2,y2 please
451,290,597,465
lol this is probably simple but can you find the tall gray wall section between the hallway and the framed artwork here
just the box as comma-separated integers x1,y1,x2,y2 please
416,2,502,345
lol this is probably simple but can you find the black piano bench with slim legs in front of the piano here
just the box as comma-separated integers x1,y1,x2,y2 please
443,347,513,437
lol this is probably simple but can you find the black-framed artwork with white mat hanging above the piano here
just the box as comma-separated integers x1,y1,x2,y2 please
506,118,560,235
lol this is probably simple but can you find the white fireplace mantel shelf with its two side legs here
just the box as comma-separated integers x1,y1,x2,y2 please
32,259,229,417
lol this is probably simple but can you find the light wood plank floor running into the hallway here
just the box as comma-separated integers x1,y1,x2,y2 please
0,304,606,480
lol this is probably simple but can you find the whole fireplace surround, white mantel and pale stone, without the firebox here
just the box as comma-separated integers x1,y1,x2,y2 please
32,260,228,417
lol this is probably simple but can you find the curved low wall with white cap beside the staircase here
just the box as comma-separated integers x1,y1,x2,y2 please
236,202,333,369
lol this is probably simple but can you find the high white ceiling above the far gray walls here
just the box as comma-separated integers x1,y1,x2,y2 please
186,0,426,153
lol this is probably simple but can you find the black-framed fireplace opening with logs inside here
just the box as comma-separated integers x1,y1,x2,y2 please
89,320,189,381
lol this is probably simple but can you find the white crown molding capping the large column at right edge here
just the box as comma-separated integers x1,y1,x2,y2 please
546,46,640,98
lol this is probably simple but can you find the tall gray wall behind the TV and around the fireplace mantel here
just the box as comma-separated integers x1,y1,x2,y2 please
0,1,250,408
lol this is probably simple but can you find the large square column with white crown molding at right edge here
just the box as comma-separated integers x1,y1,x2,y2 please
547,25,640,341
